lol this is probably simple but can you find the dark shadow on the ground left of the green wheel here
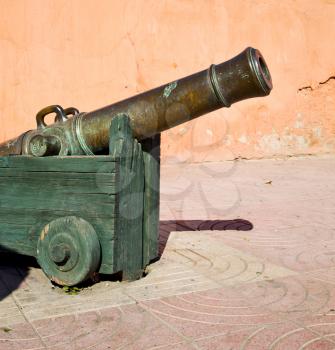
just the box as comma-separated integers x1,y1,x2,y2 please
0,245,33,301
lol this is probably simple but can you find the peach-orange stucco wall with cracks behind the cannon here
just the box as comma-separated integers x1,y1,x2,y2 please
0,0,335,162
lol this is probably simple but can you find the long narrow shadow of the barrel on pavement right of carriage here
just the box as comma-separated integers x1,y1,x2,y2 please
159,219,254,256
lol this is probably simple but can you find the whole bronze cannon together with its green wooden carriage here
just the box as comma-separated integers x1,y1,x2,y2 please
0,48,272,286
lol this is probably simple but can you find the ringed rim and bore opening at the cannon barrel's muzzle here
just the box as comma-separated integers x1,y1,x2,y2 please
247,47,272,95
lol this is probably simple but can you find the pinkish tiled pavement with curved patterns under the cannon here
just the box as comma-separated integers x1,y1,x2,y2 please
0,157,335,350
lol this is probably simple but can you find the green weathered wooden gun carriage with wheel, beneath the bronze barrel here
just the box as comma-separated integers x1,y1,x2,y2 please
0,114,160,286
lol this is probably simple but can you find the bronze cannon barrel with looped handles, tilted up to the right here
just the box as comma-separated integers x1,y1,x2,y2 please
0,47,272,156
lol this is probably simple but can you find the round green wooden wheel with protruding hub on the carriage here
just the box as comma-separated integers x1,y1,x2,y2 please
37,216,100,286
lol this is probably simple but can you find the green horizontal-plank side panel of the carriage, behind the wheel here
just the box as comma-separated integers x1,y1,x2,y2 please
0,156,116,273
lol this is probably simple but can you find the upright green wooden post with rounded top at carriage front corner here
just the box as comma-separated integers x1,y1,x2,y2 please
109,115,144,280
